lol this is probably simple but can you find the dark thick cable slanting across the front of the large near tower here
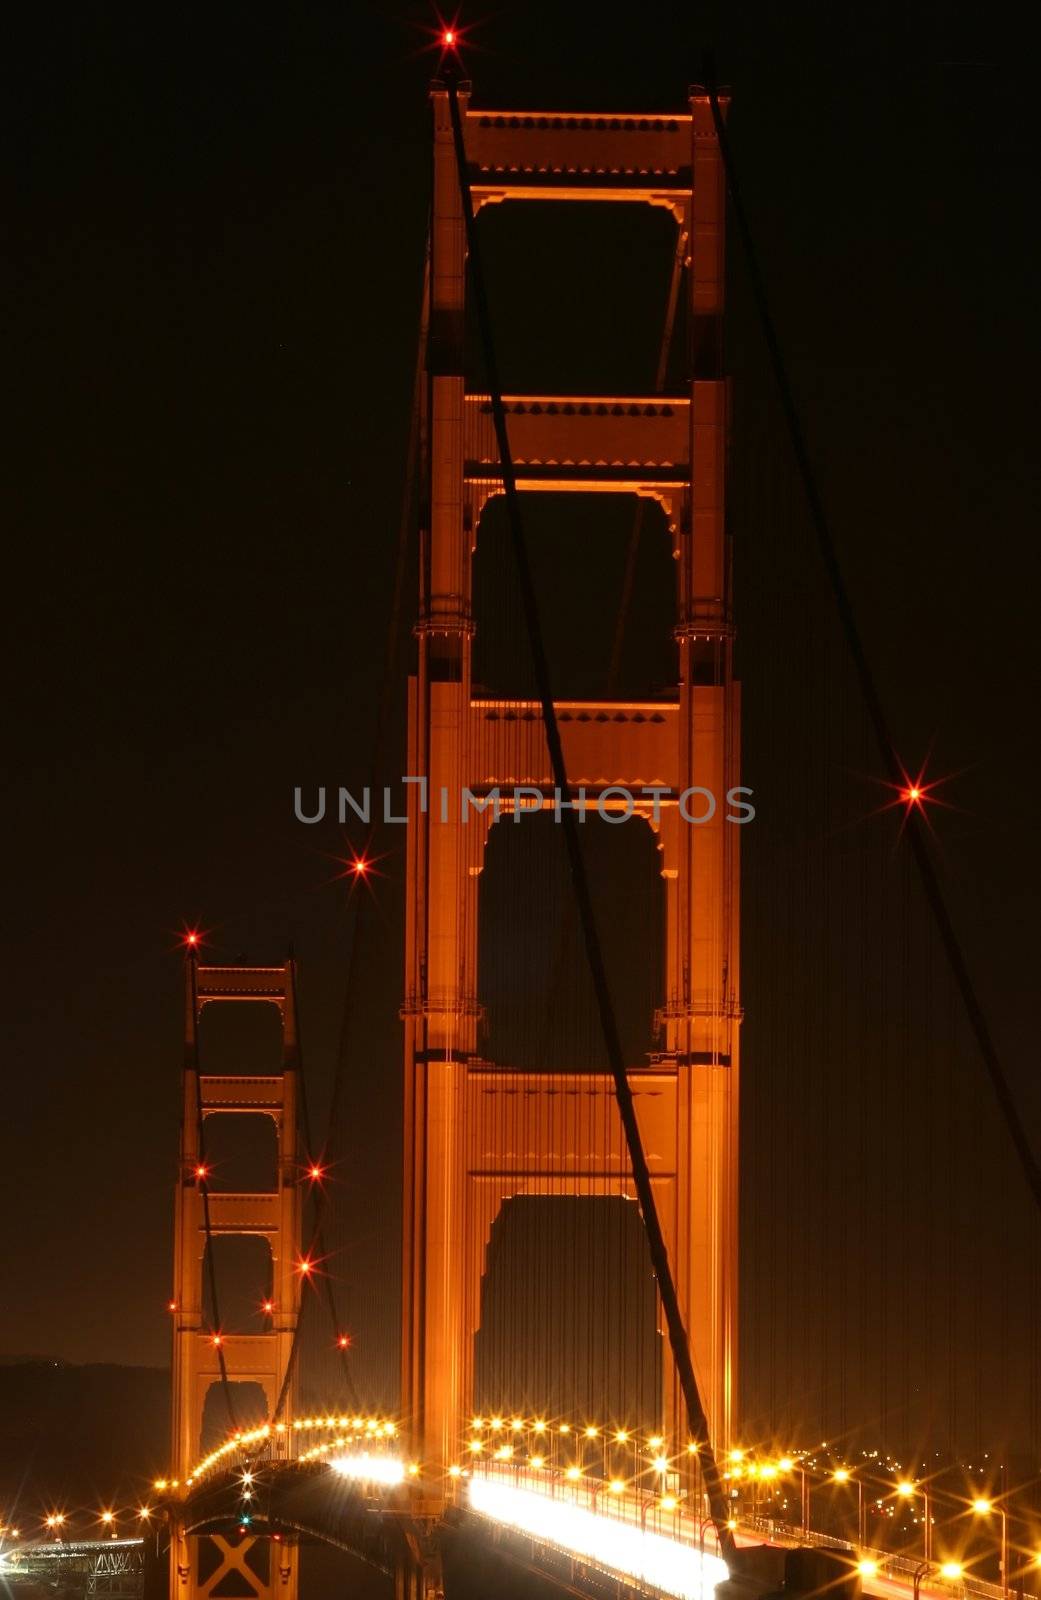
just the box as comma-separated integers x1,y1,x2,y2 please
445,72,734,1558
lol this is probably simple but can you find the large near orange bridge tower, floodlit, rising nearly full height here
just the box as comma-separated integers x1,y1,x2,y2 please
403,83,740,1484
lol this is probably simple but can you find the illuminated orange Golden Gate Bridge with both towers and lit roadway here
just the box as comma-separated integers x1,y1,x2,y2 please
10,50,1036,1600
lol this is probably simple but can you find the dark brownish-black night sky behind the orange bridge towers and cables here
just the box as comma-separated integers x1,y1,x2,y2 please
0,0,1041,1465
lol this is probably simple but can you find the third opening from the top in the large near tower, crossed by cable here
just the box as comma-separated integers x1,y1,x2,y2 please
478,810,665,1074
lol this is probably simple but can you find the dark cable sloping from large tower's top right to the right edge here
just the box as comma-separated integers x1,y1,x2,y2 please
705,54,1041,1211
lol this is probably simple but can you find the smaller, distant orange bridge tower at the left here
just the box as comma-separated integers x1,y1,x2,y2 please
170,950,302,1600
